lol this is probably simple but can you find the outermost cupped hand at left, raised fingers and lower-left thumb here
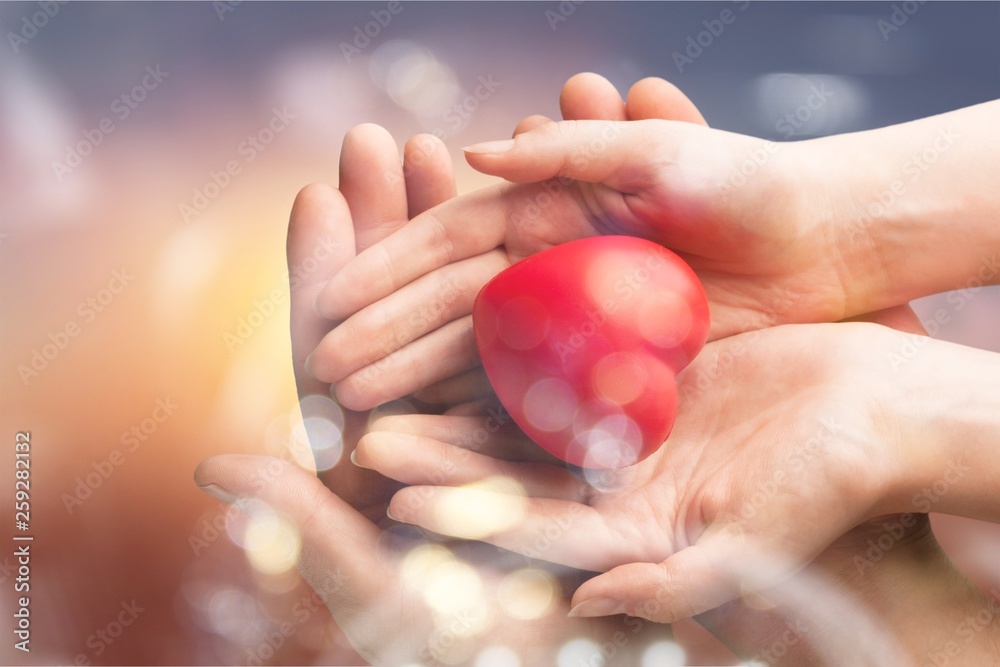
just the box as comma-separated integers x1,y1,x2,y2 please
195,81,684,665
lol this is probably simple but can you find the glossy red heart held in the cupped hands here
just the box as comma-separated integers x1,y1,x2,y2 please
473,236,709,468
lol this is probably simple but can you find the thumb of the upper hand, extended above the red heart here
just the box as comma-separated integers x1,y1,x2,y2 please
465,120,710,192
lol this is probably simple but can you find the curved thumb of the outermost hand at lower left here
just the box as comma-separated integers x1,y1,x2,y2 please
194,454,390,611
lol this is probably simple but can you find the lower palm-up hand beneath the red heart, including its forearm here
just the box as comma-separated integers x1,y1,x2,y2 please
344,73,1000,656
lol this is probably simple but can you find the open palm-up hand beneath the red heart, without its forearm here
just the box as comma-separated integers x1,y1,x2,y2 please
356,310,918,622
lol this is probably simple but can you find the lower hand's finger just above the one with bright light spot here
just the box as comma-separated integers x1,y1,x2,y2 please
355,431,589,502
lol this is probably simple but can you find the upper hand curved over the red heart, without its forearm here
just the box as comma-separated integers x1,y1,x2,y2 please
310,82,851,409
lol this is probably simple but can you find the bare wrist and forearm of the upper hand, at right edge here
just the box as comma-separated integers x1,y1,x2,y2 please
801,105,1000,316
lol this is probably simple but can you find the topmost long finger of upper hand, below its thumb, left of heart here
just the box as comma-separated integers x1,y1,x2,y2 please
316,180,592,320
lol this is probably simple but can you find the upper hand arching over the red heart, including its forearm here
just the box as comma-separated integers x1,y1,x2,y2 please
309,97,1000,409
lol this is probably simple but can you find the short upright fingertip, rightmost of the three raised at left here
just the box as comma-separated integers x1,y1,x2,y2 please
403,134,457,218
